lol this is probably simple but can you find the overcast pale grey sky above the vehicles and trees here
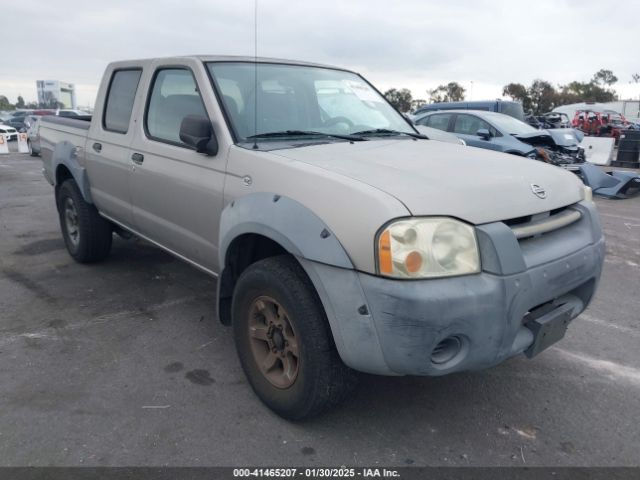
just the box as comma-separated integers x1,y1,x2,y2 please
0,0,640,106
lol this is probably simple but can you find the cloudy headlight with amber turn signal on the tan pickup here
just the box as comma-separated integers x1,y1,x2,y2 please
377,217,480,278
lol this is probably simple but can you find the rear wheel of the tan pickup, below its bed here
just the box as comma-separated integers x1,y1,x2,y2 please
56,179,113,263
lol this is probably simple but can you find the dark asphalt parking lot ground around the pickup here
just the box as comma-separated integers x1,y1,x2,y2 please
0,154,640,466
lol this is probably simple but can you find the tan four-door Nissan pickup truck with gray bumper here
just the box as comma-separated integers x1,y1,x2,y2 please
40,56,604,419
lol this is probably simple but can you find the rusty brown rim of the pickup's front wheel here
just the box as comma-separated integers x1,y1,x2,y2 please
249,296,300,388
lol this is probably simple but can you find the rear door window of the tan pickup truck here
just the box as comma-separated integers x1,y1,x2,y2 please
102,69,142,133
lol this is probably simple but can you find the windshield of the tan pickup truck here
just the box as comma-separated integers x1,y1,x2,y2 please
207,62,415,142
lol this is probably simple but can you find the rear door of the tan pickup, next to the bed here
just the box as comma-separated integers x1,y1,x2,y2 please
85,66,142,227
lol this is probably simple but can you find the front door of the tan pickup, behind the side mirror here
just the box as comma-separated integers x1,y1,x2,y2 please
129,60,227,272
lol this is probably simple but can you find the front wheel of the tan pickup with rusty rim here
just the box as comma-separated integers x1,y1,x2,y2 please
232,255,357,420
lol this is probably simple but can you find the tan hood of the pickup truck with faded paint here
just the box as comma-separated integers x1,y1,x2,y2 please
271,139,584,224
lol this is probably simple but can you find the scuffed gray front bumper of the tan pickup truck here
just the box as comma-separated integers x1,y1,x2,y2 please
302,203,605,375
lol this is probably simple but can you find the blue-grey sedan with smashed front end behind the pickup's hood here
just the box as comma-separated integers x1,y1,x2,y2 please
414,110,584,163
